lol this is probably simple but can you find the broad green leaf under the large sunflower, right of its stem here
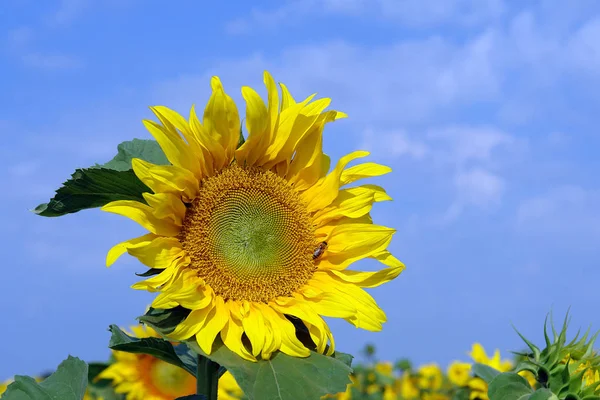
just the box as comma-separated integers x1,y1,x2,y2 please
187,340,352,400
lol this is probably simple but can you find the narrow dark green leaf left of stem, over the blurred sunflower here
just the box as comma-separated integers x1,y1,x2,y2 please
108,325,198,376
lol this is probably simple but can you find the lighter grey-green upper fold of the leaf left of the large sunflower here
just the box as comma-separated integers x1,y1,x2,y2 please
92,139,170,171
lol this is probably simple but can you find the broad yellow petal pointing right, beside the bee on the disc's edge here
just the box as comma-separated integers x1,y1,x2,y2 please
319,223,396,270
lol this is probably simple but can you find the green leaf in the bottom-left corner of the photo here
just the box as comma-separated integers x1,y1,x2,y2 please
2,356,88,400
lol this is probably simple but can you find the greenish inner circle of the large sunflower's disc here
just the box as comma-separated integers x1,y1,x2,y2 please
210,189,293,277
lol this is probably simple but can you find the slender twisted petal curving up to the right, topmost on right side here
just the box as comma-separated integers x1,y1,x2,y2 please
300,151,369,211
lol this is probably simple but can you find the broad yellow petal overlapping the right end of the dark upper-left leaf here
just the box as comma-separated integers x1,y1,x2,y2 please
131,158,199,202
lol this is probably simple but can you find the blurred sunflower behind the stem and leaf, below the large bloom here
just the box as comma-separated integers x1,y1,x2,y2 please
96,326,242,400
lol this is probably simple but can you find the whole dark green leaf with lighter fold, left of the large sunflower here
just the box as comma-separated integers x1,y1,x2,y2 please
33,139,168,217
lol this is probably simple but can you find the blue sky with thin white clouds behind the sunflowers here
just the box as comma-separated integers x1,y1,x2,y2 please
0,0,600,379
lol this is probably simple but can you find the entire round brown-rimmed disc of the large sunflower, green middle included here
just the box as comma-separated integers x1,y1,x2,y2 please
180,164,315,302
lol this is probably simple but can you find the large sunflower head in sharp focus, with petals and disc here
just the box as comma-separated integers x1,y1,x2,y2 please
102,72,404,361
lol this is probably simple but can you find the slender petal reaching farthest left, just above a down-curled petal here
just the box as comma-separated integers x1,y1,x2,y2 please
101,200,180,236
